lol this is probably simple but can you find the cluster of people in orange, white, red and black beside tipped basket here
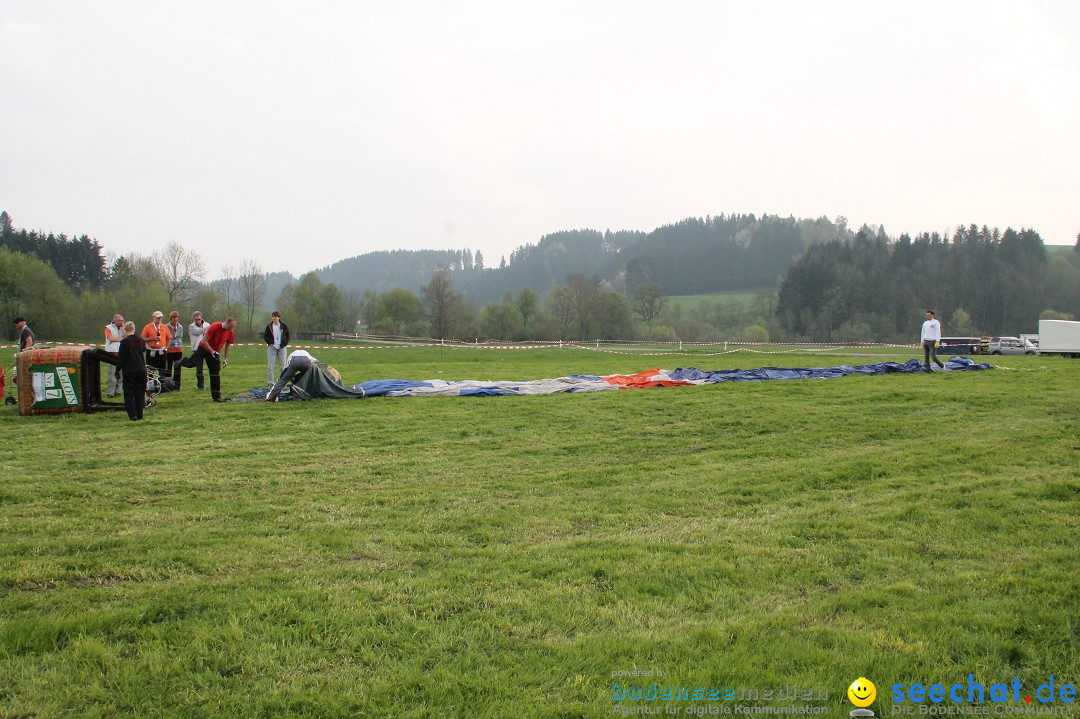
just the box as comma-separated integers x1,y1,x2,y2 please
105,310,237,420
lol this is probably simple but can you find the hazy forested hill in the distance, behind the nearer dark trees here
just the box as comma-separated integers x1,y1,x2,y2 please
304,215,853,304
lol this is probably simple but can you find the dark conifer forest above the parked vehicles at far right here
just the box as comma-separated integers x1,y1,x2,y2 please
777,225,1080,341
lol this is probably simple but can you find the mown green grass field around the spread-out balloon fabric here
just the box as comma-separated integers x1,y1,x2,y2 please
0,348,1080,718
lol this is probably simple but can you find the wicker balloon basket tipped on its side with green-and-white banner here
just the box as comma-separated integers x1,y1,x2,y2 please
15,345,123,417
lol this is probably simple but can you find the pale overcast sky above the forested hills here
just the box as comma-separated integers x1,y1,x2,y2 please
0,0,1080,276
